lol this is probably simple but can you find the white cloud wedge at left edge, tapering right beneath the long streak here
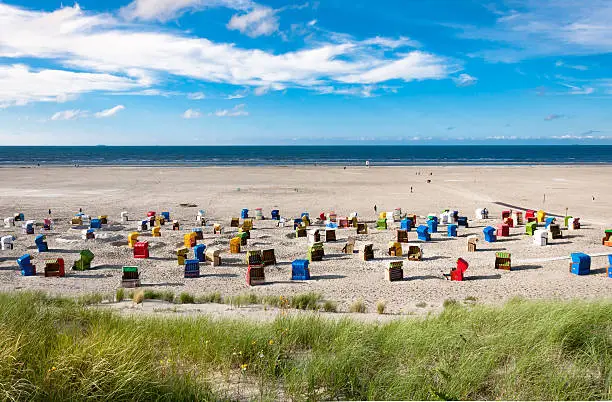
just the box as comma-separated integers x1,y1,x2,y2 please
0,63,140,108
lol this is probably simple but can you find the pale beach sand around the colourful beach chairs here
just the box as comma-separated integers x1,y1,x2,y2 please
0,166,612,313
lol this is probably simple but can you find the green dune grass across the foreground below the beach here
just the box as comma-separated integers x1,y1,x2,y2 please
0,292,612,400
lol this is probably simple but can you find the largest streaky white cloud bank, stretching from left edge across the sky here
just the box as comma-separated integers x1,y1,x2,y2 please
0,1,458,104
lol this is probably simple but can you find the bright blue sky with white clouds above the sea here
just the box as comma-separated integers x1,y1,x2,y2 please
0,0,612,145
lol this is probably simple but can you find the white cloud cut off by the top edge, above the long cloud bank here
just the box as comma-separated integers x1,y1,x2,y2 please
121,0,253,22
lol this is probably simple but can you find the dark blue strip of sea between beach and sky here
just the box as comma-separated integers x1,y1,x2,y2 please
0,145,612,166
